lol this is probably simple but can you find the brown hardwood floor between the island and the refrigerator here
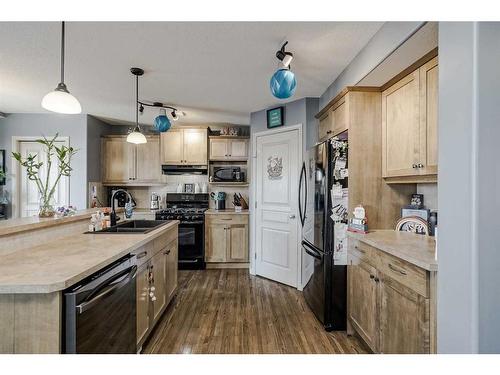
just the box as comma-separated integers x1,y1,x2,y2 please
143,269,366,354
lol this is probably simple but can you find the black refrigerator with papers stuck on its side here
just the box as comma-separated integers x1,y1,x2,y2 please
299,134,348,331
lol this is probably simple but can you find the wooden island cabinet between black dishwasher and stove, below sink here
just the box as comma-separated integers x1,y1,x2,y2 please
136,235,178,349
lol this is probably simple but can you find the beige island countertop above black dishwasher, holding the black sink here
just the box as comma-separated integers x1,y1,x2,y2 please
0,220,179,294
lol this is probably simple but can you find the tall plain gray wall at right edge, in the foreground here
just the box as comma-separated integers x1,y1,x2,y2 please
438,22,500,353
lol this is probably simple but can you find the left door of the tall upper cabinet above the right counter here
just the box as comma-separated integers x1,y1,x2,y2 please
382,70,420,177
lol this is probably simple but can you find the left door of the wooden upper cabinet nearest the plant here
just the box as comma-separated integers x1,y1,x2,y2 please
102,138,135,183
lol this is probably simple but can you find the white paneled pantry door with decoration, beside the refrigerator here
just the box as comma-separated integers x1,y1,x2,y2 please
255,129,302,287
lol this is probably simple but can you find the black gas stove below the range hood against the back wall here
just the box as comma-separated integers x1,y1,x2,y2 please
156,193,208,269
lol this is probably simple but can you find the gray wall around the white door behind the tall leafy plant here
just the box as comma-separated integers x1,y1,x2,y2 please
0,114,87,214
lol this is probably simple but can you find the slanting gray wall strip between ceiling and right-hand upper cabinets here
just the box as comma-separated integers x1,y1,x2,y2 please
319,22,423,109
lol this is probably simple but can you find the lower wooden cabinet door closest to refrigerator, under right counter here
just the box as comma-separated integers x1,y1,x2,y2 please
348,257,379,352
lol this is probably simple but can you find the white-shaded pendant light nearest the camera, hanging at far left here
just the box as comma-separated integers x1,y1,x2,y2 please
42,21,82,114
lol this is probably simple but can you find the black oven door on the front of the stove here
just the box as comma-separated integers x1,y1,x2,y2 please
179,221,205,269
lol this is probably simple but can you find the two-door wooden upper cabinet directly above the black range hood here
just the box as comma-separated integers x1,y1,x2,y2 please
161,128,208,165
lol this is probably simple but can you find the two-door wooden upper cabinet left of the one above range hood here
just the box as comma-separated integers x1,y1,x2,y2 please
101,136,161,185
